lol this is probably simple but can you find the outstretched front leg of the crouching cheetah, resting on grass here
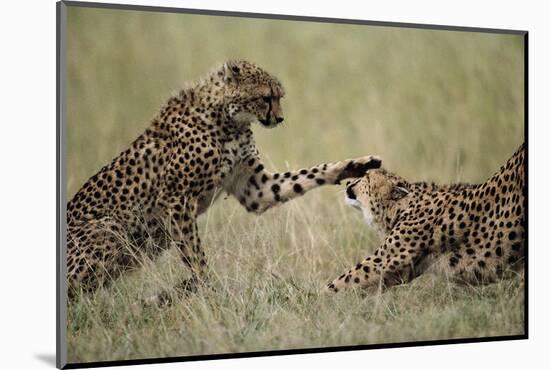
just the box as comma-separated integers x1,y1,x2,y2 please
324,232,431,293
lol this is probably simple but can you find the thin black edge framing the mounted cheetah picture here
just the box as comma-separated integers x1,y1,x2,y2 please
56,1,529,369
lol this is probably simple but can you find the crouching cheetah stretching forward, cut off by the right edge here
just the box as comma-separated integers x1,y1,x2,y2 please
325,145,526,292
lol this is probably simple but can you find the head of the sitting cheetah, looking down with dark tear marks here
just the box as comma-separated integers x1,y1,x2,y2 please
222,61,284,128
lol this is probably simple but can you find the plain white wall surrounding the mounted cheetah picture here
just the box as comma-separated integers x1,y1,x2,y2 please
0,0,550,370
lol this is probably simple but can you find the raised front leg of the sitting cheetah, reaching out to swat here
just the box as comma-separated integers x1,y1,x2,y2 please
231,156,382,214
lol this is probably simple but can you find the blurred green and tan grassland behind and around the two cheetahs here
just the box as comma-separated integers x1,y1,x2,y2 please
67,7,524,362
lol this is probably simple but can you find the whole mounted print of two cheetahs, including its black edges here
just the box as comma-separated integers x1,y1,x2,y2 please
57,2,527,368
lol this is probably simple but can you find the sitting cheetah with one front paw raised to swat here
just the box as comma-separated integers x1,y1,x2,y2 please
67,61,380,296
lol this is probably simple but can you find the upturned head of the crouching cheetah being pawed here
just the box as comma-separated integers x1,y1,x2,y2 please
345,169,410,233
